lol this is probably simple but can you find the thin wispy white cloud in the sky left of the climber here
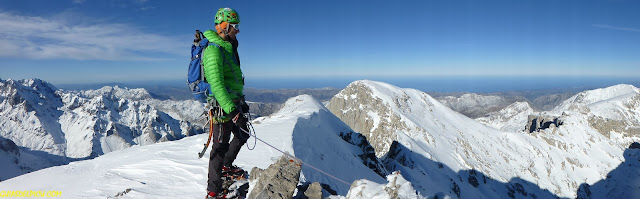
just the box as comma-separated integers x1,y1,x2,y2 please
0,12,187,61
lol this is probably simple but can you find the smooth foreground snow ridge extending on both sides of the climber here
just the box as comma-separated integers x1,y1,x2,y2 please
0,95,408,198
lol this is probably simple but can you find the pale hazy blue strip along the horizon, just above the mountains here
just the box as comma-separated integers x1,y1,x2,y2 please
11,76,640,93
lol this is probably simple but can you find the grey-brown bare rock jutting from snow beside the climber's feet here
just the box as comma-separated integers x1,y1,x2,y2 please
249,156,301,199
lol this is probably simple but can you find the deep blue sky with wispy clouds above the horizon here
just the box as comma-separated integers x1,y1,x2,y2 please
0,0,640,84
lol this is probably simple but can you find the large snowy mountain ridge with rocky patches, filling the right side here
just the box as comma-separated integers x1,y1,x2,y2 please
328,80,640,198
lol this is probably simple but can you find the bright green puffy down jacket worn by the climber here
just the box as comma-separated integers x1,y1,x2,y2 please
202,30,244,113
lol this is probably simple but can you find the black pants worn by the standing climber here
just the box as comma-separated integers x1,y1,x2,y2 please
207,117,249,193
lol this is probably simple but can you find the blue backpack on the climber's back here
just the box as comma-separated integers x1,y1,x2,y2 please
187,30,224,102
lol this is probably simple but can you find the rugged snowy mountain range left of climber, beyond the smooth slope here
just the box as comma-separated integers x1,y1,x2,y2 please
0,79,204,179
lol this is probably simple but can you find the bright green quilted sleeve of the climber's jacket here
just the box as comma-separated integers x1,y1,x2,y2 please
202,45,236,113
